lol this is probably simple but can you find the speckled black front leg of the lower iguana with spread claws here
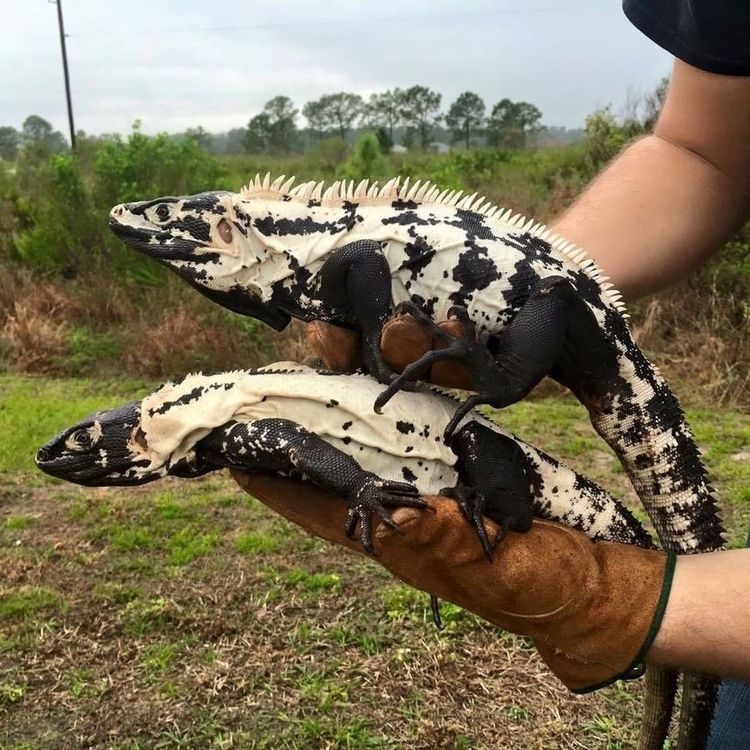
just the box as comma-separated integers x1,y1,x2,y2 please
196,419,425,554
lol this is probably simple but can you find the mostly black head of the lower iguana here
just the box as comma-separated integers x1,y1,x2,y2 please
36,401,176,487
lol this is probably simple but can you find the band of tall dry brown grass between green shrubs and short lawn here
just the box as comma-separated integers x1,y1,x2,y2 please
0,262,750,405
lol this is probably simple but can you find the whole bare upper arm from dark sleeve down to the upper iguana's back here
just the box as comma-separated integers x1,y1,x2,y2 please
553,60,750,299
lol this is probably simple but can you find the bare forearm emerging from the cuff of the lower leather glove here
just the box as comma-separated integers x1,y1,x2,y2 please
646,549,750,679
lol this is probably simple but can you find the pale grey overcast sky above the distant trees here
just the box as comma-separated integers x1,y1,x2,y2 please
0,0,671,134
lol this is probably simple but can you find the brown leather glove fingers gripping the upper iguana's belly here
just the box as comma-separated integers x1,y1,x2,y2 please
307,315,471,389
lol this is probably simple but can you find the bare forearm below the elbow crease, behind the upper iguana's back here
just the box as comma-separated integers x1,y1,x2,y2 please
553,135,746,299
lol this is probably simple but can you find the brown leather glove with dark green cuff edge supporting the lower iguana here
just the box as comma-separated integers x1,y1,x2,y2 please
234,472,674,692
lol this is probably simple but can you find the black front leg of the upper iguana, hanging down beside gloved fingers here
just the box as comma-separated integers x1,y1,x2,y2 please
320,240,400,388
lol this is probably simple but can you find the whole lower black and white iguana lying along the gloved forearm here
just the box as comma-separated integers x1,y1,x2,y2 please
36,363,651,553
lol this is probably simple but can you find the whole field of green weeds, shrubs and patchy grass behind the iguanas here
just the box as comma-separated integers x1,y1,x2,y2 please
0,103,750,750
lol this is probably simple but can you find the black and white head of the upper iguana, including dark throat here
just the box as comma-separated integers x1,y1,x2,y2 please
109,192,291,331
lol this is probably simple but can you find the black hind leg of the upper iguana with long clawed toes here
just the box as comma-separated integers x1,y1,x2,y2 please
375,276,617,436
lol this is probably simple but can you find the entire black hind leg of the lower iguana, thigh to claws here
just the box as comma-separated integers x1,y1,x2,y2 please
440,421,534,561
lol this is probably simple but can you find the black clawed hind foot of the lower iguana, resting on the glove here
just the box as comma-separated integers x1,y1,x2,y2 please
440,483,532,562
